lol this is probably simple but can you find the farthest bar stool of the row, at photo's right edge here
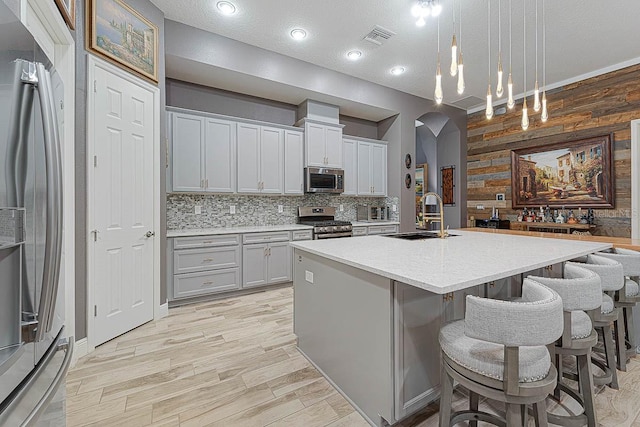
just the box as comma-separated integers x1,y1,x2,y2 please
598,248,640,358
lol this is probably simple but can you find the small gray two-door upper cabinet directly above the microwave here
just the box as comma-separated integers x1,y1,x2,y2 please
304,120,342,169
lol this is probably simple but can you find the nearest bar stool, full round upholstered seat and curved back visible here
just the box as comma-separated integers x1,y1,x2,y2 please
439,279,563,427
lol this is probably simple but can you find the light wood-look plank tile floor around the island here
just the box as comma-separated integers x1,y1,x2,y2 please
67,287,640,427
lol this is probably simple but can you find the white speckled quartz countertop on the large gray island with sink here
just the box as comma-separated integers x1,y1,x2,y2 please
291,230,612,294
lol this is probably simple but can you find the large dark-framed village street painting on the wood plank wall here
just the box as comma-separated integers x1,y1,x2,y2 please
511,134,615,209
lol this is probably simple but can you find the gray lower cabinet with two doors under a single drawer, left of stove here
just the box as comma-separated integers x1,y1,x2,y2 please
242,232,291,288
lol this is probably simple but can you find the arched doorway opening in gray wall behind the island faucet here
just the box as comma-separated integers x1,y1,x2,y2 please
415,113,467,228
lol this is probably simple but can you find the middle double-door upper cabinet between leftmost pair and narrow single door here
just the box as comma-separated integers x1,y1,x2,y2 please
238,123,284,194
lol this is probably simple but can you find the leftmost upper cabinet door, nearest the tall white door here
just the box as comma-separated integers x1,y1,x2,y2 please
171,113,204,191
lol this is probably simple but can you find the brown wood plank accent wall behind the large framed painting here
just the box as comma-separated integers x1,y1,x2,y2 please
467,65,640,237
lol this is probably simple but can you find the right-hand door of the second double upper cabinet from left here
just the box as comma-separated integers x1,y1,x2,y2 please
260,126,284,194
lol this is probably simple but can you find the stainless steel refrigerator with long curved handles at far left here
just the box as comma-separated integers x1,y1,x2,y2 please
0,1,73,426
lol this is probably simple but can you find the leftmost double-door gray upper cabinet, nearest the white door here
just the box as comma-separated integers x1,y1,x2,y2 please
169,112,236,193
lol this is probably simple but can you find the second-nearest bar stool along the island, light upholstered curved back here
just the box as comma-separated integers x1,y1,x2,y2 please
529,262,602,426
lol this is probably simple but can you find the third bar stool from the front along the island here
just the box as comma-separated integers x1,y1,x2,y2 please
576,254,626,390
